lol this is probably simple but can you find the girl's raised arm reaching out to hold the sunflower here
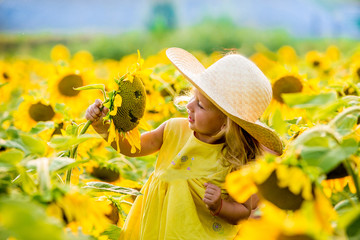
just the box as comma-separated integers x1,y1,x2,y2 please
85,99,166,157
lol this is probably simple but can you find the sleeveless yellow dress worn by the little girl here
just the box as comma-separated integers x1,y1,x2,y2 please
120,118,238,240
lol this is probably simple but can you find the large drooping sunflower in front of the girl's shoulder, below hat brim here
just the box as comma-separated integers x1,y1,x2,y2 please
226,155,313,210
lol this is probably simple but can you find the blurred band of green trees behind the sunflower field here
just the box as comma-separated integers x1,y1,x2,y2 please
0,17,358,60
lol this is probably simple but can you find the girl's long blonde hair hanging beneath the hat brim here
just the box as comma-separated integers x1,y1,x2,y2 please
220,117,262,171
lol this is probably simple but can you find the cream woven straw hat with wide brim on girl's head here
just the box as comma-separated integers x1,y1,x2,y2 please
166,48,282,154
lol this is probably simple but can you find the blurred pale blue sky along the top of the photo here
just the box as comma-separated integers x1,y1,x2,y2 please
0,0,360,38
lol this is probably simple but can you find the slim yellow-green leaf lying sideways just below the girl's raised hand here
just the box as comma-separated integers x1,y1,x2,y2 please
48,134,100,151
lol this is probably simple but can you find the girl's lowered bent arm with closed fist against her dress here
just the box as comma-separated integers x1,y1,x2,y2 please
203,183,259,225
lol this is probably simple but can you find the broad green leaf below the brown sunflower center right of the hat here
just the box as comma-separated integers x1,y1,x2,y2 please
281,92,337,108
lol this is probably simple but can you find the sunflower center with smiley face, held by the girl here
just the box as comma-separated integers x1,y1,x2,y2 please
113,77,146,132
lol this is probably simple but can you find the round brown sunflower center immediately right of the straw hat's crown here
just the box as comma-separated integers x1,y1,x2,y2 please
273,76,303,103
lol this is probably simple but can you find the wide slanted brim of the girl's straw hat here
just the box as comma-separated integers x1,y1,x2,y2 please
166,48,283,155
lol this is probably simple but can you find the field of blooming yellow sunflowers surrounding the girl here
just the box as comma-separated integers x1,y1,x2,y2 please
0,45,360,240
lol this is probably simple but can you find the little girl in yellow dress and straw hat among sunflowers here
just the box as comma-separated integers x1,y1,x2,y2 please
86,48,282,240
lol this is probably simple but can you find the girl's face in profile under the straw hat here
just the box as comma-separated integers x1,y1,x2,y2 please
186,89,226,143
